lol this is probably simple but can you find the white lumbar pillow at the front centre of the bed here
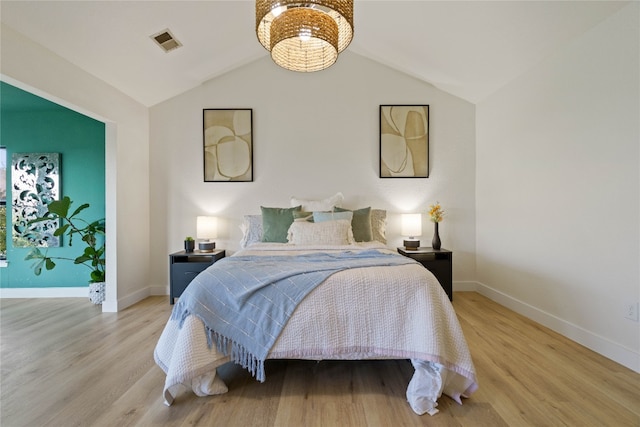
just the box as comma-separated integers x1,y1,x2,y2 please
287,219,354,245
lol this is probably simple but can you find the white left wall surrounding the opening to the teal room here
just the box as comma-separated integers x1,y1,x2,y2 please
1,25,149,311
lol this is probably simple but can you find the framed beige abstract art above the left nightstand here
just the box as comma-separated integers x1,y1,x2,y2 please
202,108,253,182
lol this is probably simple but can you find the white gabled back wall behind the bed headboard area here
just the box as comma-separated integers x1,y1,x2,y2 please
150,51,475,293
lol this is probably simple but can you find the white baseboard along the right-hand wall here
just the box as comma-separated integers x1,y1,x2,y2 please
472,282,640,373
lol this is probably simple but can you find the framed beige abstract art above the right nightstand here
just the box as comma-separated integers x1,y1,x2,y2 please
380,105,429,178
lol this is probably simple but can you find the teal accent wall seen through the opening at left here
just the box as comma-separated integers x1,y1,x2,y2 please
0,82,105,288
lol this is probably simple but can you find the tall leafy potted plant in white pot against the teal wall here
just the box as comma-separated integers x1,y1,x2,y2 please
25,196,105,304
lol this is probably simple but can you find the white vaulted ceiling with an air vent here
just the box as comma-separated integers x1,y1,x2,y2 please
0,0,629,106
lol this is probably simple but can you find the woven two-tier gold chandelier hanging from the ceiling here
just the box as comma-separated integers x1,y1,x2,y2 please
256,0,353,72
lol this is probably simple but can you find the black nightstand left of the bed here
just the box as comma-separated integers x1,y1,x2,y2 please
169,249,225,304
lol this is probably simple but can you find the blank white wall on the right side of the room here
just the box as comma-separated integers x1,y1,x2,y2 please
477,3,640,371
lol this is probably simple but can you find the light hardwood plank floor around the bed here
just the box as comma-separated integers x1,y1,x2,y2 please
0,292,640,427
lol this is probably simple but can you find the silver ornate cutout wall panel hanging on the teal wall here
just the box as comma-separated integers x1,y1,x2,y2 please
11,153,61,247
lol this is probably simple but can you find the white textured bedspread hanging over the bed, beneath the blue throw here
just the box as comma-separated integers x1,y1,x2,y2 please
154,244,477,414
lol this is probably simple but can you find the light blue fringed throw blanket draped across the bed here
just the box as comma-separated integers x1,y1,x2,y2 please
171,250,415,382
